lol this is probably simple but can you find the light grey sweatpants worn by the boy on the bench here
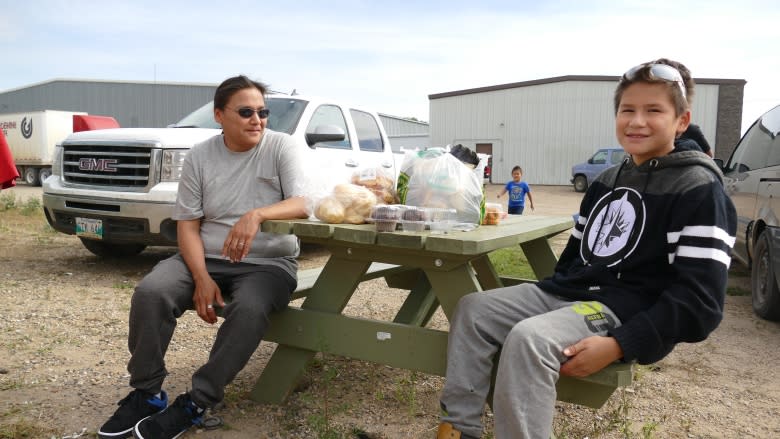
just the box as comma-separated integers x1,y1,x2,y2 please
441,284,620,439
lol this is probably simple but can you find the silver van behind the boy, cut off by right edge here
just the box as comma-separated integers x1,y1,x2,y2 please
723,105,780,320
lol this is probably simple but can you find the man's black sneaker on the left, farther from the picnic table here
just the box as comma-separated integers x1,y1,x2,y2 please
98,389,168,439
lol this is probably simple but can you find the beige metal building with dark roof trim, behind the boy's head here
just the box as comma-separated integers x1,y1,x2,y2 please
428,76,745,185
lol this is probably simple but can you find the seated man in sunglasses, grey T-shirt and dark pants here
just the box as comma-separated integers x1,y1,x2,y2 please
98,76,307,439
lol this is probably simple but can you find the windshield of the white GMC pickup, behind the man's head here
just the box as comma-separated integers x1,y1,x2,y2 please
173,96,309,134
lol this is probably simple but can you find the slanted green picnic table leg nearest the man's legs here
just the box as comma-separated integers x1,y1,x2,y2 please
250,256,371,404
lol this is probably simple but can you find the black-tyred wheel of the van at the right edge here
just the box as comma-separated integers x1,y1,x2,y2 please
750,232,780,321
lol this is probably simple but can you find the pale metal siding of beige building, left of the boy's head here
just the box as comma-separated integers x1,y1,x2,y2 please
430,82,616,184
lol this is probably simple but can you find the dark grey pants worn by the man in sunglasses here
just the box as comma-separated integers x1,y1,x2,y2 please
127,254,297,408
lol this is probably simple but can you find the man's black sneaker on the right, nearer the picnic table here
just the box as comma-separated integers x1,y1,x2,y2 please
133,393,204,439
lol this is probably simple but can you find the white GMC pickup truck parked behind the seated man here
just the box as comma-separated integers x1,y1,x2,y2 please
43,95,400,256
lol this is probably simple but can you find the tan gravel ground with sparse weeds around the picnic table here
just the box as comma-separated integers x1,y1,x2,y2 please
0,186,780,439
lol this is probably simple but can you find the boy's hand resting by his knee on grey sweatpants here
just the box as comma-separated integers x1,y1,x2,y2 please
561,335,623,378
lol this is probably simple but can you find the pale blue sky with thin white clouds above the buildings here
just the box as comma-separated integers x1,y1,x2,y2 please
0,0,780,131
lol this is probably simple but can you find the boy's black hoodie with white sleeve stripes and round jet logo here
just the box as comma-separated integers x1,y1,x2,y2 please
539,151,737,364
